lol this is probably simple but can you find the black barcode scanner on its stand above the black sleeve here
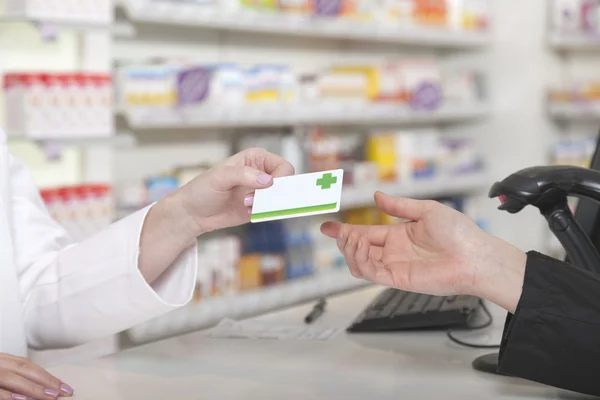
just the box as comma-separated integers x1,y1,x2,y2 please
489,166,600,273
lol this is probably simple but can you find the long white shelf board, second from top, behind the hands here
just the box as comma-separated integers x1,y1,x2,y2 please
120,103,489,131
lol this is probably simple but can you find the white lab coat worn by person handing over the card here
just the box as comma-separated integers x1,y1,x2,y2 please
0,130,197,356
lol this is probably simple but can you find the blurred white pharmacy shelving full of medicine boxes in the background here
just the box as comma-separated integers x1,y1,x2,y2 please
0,0,584,363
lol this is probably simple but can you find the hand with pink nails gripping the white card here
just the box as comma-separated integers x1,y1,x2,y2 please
177,148,294,235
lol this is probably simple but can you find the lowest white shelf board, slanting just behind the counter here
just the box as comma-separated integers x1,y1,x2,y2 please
127,269,368,344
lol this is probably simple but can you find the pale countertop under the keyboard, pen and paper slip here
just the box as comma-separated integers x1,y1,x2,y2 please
50,286,591,400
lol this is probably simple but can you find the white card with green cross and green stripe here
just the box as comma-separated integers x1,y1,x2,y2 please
250,169,344,223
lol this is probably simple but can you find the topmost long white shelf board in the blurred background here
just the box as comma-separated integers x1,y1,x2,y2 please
121,2,489,48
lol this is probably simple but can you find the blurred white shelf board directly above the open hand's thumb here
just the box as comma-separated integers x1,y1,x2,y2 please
342,172,492,209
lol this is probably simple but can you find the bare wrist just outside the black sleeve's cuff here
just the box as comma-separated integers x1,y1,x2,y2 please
472,234,527,313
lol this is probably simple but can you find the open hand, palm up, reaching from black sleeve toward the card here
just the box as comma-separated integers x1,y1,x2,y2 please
321,193,526,311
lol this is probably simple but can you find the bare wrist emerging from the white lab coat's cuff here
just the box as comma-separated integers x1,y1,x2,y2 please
138,196,200,284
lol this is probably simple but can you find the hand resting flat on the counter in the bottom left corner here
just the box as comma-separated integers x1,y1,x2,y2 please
0,353,73,400
